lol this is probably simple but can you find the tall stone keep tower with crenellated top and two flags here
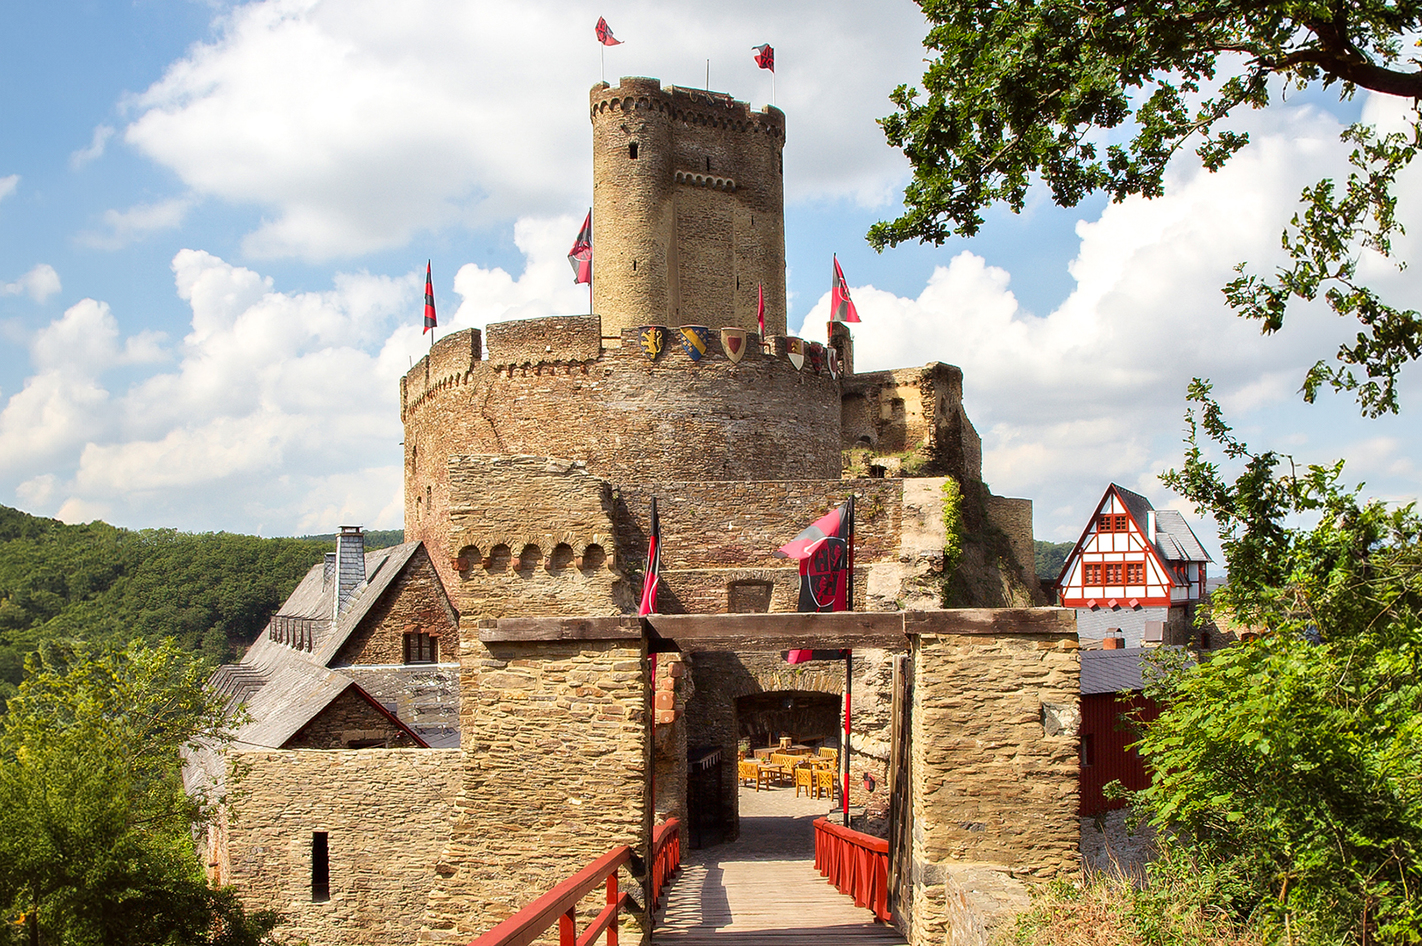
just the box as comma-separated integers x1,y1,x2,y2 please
590,78,785,336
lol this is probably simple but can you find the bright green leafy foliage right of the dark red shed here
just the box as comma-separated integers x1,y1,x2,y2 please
1139,381,1422,943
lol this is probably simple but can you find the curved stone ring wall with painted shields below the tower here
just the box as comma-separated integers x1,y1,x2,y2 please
401,326,842,586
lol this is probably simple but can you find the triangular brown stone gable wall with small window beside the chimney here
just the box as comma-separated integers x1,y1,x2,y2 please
330,548,459,667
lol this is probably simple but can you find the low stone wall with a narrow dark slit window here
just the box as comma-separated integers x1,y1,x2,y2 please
218,750,459,946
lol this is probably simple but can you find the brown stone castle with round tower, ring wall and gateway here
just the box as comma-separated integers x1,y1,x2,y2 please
191,78,1078,946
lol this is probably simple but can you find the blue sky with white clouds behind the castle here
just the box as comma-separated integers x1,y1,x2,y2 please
0,0,1422,557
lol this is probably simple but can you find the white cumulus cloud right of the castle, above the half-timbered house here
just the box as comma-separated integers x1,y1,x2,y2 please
802,97,1422,539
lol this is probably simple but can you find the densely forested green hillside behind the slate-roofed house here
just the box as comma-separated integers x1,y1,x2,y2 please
0,506,401,701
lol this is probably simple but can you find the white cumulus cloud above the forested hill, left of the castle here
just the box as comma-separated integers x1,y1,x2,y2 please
0,249,422,533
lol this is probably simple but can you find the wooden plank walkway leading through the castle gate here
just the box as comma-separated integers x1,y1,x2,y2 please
653,788,906,946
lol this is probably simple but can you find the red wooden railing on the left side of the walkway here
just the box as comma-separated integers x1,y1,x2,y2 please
469,818,681,946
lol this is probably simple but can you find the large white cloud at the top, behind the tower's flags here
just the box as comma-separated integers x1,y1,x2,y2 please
124,0,923,260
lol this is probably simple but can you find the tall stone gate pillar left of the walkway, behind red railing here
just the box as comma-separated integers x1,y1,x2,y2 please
419,619,651,943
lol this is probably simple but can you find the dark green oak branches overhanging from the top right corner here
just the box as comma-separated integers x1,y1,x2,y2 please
869,0,1422,415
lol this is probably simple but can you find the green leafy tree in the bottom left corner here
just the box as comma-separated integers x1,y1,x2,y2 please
0,642,276,946
